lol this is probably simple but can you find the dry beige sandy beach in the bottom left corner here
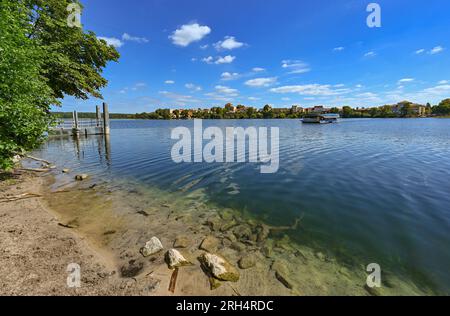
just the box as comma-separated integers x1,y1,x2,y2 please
0,174,153,295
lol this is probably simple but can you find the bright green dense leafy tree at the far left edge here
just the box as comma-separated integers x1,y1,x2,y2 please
0,1,56,170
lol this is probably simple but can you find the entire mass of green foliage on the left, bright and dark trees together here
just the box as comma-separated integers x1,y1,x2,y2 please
0,0,119,169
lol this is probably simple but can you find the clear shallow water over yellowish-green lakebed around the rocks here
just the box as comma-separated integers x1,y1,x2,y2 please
39,175,430,295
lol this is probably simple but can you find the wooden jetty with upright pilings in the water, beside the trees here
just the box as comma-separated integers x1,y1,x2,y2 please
72,103,111,136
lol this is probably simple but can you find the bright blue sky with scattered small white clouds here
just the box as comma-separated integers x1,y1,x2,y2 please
58,0,450,113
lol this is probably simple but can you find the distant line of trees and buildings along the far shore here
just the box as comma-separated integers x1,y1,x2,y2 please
54,99,450,120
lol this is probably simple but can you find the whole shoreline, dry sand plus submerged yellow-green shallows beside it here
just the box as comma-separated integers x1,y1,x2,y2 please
0,160,438,296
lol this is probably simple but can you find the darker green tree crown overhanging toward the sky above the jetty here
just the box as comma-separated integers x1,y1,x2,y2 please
25,0,119,100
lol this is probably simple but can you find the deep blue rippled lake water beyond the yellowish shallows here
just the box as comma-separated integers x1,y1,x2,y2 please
35,119,450,294
